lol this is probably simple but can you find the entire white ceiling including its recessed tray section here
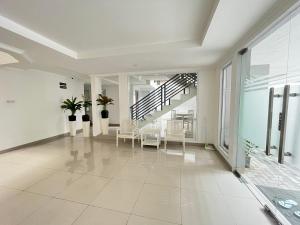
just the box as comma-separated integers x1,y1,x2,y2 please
0,0,280,76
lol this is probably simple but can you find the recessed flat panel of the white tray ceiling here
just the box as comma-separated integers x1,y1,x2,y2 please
0,0,214,52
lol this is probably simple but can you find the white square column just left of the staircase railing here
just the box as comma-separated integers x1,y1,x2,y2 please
119,74,130,124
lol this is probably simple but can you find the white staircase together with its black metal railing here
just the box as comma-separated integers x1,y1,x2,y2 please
130,73,197,128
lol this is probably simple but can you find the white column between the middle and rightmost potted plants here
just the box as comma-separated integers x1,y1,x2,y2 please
90,75,102,136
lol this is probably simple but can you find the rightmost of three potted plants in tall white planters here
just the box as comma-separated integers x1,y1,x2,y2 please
96,94,114,134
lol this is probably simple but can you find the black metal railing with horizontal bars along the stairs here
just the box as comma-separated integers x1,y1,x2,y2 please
130,73,197,120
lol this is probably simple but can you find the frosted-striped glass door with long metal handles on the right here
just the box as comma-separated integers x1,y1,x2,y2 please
237,7,300,224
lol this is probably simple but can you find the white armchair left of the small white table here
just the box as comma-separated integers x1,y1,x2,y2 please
116,120,139,148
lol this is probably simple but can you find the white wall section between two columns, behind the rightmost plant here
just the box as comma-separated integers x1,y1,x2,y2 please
102,85,120,124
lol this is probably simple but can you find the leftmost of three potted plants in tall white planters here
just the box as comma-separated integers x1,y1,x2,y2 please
60,97,82,136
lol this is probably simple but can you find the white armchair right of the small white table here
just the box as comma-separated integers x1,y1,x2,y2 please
165,120,185,152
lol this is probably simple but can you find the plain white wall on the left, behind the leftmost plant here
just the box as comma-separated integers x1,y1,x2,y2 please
0,68,83,151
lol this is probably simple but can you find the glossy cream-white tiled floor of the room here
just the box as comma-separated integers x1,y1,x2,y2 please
0,136,272,225
